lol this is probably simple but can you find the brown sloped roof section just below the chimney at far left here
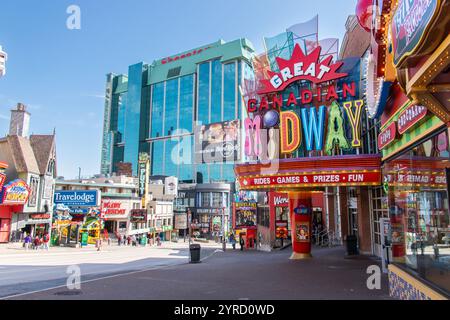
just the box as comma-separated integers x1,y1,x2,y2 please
6,135,39,173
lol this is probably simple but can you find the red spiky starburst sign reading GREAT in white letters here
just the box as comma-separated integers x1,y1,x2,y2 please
258,44,348,94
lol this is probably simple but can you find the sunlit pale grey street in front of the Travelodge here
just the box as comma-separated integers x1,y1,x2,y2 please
0,243,219,298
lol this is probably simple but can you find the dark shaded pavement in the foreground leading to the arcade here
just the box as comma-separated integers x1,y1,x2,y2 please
3,247,389,300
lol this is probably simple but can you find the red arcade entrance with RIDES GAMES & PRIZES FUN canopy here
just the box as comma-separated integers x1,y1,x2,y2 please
235,155,381,259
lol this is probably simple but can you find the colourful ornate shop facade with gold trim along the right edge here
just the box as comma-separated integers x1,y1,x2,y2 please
359,0,450,300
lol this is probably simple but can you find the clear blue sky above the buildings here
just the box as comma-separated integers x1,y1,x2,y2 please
0,0,356,178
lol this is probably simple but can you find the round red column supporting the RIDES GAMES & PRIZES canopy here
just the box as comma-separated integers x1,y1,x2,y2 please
289,192,312,259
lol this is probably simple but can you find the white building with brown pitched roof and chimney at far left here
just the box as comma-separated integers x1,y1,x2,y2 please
0,103,57,241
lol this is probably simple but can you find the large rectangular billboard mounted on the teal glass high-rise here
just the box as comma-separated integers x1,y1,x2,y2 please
194,120,240,163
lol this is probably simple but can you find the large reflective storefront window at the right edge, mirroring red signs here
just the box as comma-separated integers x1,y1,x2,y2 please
384,131,450,291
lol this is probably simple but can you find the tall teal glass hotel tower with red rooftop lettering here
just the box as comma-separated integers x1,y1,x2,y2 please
101,39,254,183
